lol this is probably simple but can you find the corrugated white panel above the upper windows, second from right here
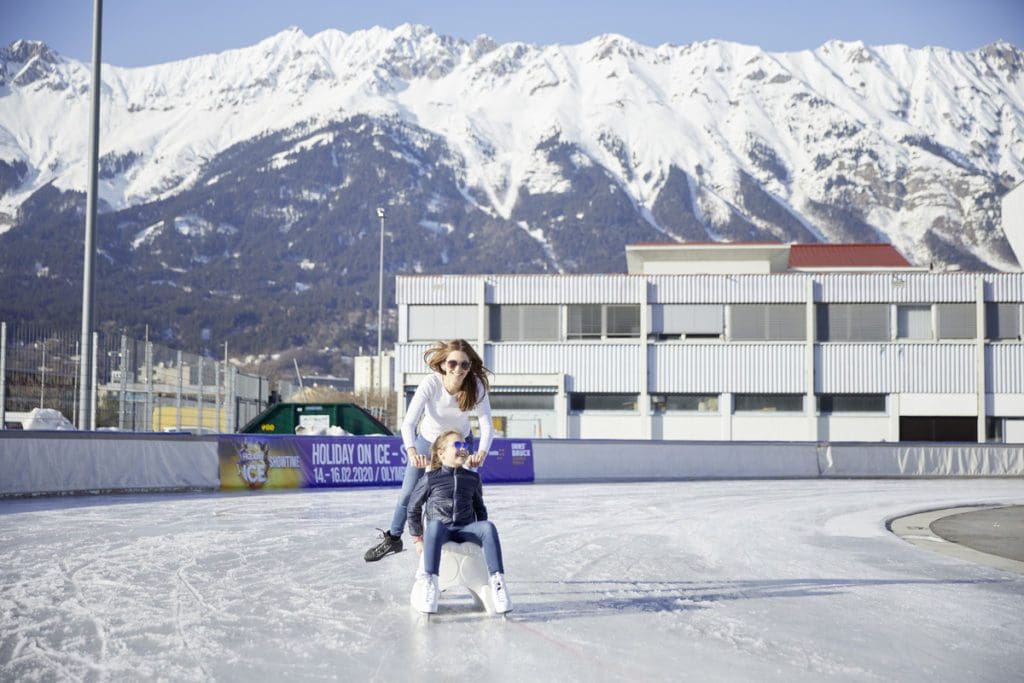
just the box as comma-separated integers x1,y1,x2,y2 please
814,271,976,303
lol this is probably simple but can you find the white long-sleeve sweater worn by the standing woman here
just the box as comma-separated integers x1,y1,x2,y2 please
401,373,495,456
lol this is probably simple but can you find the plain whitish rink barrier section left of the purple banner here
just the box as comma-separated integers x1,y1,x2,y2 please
0,431,220,496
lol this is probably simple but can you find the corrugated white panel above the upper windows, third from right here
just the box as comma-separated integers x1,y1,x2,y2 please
648,274,810,303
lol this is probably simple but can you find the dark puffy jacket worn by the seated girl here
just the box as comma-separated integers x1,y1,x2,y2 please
409,467,487,536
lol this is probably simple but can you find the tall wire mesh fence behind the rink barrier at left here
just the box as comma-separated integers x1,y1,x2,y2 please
0,323,271,433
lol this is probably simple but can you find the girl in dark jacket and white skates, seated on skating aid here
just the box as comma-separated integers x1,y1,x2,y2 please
409,429,512,614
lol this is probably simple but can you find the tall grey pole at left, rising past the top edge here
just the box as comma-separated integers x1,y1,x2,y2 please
78,0,103,429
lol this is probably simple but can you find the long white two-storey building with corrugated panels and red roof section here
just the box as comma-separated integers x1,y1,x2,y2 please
395,244,1024,442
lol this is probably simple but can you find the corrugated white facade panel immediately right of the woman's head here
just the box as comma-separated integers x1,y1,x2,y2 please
488,343,644,393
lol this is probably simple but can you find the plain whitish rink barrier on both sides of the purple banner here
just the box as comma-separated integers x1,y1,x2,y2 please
0,431,1024,496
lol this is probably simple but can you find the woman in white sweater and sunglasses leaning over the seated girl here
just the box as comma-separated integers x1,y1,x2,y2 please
364,339,494,562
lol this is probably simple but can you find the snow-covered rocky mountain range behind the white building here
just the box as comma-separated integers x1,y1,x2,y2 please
0,25,1024,368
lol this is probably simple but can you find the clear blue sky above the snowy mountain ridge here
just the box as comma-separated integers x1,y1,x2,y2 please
0,0,1024,67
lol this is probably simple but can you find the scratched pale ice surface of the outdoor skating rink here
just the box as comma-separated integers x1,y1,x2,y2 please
0,479,1024,683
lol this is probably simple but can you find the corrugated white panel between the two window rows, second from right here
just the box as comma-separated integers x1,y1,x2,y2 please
814,343,976,393
